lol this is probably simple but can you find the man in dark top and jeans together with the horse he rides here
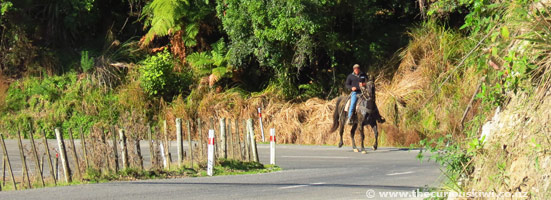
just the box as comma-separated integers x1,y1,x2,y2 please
329,64,385,153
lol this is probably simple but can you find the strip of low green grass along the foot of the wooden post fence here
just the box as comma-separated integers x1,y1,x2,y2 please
0,159,281,191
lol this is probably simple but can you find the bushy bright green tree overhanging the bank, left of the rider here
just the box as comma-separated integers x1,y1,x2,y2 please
217,0,417,97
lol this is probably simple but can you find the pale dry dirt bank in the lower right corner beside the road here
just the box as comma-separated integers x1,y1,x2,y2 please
467,88,551,199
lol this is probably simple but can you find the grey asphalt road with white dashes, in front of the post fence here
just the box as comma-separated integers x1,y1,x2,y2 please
0,145,441,199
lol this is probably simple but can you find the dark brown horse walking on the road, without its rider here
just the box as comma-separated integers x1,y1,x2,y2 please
329,81,384,154
